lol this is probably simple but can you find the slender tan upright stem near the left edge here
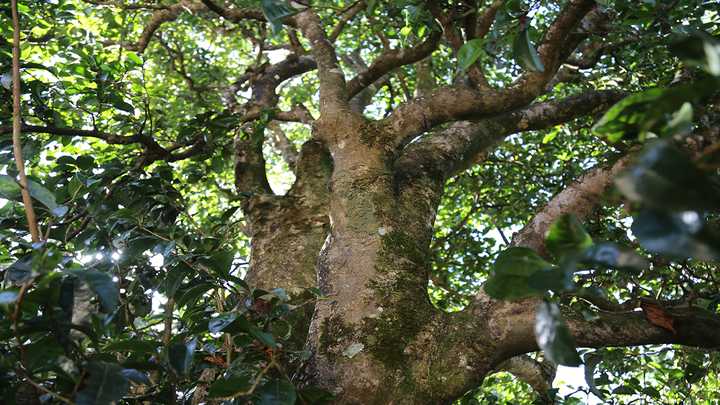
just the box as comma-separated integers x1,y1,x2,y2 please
10,0,40,242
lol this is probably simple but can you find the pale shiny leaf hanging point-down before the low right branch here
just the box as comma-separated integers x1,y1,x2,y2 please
535,301,582,367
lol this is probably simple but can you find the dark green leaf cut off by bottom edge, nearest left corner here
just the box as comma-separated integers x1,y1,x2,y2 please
75,362,130,405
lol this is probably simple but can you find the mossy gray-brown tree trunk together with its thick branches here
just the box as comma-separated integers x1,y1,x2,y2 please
217,0,720,404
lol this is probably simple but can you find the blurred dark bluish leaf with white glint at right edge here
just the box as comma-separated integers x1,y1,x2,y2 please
632,210,720,261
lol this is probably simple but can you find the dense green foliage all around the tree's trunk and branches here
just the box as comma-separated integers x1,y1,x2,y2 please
0,0,720,404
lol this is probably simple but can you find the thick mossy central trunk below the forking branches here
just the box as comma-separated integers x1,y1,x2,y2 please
290,118,493,404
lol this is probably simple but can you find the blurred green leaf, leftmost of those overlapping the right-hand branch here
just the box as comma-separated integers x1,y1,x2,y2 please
484,247,553,300
